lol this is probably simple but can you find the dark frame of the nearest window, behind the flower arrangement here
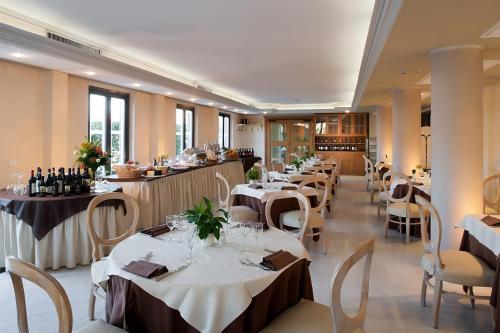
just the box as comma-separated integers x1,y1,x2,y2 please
87,86,130,163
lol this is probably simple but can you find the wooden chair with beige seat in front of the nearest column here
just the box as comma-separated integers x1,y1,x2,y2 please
415,195,496,328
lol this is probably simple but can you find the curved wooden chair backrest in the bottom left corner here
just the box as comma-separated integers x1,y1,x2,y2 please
5,256,73,333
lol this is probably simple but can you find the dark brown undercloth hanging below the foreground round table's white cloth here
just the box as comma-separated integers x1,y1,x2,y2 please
106,255,313,333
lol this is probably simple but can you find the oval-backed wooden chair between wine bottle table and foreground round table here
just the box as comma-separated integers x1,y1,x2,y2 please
87,192,139,320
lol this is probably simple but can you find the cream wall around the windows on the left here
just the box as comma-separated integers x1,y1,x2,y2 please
0,61,223,188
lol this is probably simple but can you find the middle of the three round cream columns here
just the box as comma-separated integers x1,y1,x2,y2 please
392,87,422,175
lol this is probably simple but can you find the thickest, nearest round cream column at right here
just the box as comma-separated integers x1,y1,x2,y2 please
431,46,483,249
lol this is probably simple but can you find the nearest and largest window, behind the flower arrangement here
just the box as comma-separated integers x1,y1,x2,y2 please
89,87,128,164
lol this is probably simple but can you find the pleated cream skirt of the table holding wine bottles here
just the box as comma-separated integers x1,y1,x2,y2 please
0,206,126,269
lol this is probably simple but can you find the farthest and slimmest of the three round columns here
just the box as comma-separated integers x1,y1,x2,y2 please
377,106,392,164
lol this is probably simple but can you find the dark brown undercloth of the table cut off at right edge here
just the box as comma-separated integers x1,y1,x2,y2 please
460,231,500,333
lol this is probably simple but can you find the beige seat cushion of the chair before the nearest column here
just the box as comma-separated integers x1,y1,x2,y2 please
420,251,495,287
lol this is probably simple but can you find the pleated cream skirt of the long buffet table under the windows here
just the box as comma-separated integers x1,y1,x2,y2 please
113,161,245,228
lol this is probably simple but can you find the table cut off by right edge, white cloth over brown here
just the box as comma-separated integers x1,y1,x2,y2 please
457,214,500,333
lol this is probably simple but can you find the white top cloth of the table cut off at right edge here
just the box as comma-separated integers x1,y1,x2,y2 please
457,215,500,255
